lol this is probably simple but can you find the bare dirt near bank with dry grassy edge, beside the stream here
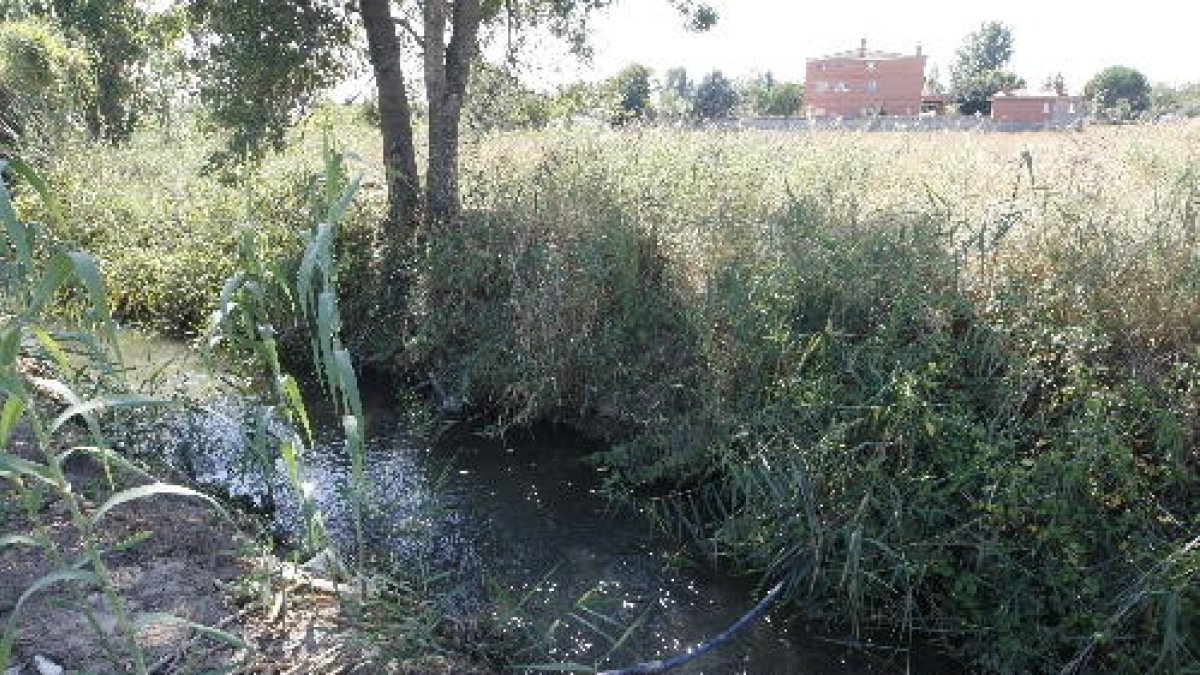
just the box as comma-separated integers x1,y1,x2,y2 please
0,417,500,675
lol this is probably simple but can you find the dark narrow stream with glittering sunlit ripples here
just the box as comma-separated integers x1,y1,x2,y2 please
119,331,936,675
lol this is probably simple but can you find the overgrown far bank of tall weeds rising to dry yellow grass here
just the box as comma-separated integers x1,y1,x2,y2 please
21,119,1200,671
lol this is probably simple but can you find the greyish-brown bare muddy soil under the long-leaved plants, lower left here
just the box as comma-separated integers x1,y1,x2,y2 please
0,425,491,675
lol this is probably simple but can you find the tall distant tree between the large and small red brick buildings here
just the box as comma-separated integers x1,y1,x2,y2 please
950,22,1025,115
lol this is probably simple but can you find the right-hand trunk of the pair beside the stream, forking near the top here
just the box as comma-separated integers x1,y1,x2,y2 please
425,0,482,227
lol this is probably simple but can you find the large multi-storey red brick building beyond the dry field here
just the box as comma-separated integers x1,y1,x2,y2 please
804,40,926,118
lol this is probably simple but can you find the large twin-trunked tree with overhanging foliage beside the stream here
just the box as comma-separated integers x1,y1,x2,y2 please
194,0,716,236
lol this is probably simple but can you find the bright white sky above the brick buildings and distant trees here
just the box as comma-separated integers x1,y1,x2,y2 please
528,0,1200,92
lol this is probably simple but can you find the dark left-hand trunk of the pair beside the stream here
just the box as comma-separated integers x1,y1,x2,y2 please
361,0,421,239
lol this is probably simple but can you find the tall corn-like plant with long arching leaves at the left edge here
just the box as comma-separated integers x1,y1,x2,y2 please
0,160,246,674
